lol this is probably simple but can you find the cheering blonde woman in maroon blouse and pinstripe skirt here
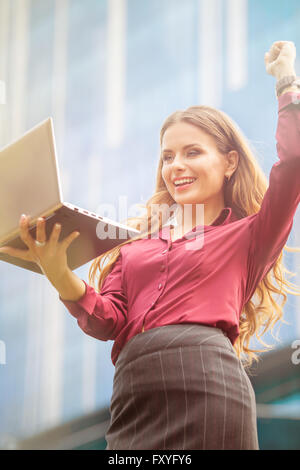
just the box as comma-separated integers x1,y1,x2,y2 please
1,41,300,450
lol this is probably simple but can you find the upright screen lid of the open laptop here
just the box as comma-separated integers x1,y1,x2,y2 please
0,118,62,241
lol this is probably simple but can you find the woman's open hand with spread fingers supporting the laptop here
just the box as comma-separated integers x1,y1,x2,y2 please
0,214,79,280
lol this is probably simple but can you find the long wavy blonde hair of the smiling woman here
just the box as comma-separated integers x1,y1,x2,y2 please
89,106,300,367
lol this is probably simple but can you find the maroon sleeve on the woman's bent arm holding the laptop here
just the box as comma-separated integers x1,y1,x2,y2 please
59,253,127,341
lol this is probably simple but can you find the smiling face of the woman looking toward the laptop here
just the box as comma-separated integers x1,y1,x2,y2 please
161,122,234,224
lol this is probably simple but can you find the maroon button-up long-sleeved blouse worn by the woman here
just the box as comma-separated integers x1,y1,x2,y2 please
59,92,300,364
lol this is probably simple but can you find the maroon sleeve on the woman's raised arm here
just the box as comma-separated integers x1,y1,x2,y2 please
245,93,300,303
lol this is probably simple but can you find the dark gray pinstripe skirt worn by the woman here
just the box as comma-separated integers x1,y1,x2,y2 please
105,323,258,450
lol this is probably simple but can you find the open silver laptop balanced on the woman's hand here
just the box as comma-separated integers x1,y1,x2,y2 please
0,118,140,274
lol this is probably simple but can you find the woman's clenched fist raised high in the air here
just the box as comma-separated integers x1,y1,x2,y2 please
265,41,296,80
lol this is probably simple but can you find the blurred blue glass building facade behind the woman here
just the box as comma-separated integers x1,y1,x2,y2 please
0,0,300,449
